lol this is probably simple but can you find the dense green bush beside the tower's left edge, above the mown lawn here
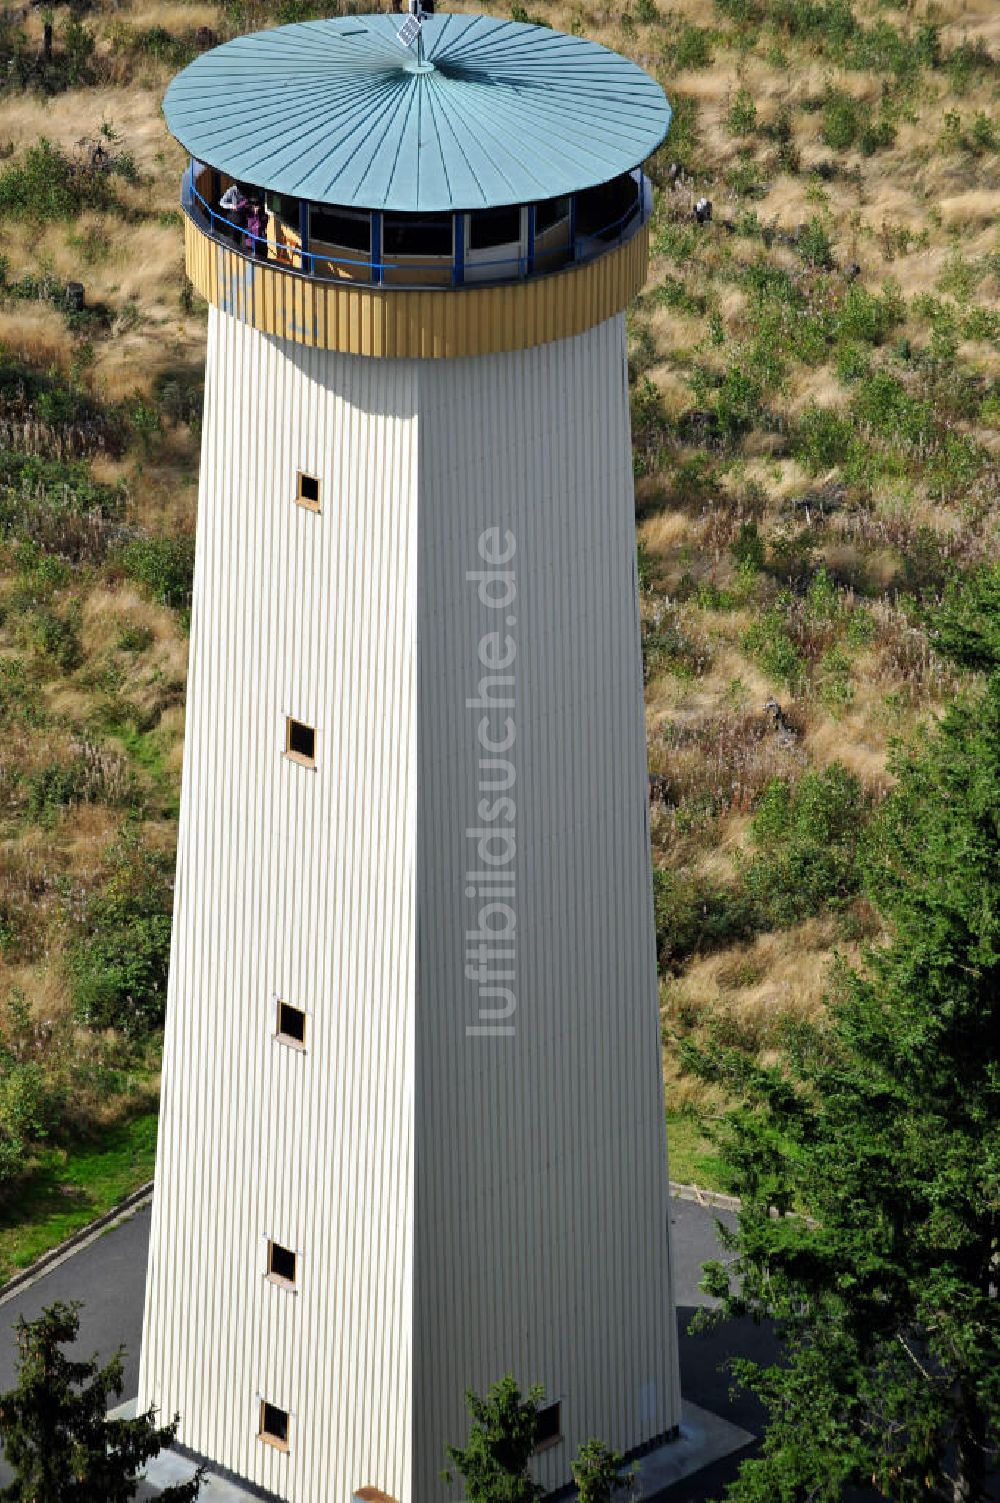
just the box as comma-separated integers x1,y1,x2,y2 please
69,833,171,1034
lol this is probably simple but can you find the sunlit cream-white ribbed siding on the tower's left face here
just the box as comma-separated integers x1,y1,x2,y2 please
140,310,417,1503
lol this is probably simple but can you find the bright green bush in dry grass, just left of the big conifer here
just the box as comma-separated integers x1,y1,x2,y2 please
743,762,868,929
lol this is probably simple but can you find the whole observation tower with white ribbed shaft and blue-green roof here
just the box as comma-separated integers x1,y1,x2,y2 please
140,14,680,1503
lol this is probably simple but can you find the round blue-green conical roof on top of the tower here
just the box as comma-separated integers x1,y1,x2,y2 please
164,15,671,212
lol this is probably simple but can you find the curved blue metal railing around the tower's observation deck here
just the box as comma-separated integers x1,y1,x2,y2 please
180,162,651,292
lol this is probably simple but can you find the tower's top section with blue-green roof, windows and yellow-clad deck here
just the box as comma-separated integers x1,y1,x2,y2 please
164,15,671,356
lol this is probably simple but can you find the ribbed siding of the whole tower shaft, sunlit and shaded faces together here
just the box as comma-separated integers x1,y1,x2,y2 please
140,311,678,1503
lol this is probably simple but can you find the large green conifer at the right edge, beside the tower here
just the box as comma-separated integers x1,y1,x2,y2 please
687,586,1000,1503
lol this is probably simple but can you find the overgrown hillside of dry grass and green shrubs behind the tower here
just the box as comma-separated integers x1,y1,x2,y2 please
0,0,1000,1244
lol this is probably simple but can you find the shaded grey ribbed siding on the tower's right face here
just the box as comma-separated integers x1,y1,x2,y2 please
414,317,680,1503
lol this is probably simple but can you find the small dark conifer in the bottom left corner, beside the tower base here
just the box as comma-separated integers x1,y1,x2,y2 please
0,1303,202,1503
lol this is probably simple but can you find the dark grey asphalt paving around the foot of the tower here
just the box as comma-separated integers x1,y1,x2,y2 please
0,1199,774,1503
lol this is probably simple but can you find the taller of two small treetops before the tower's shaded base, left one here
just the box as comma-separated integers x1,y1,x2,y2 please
444,1372,544,1503
